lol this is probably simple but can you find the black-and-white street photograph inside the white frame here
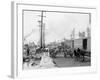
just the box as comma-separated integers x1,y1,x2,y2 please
22,9,91,70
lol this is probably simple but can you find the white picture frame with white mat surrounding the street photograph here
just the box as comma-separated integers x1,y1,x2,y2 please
11,2,97,78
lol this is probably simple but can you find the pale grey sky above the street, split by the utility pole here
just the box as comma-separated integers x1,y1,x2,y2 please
23,11,89,44
